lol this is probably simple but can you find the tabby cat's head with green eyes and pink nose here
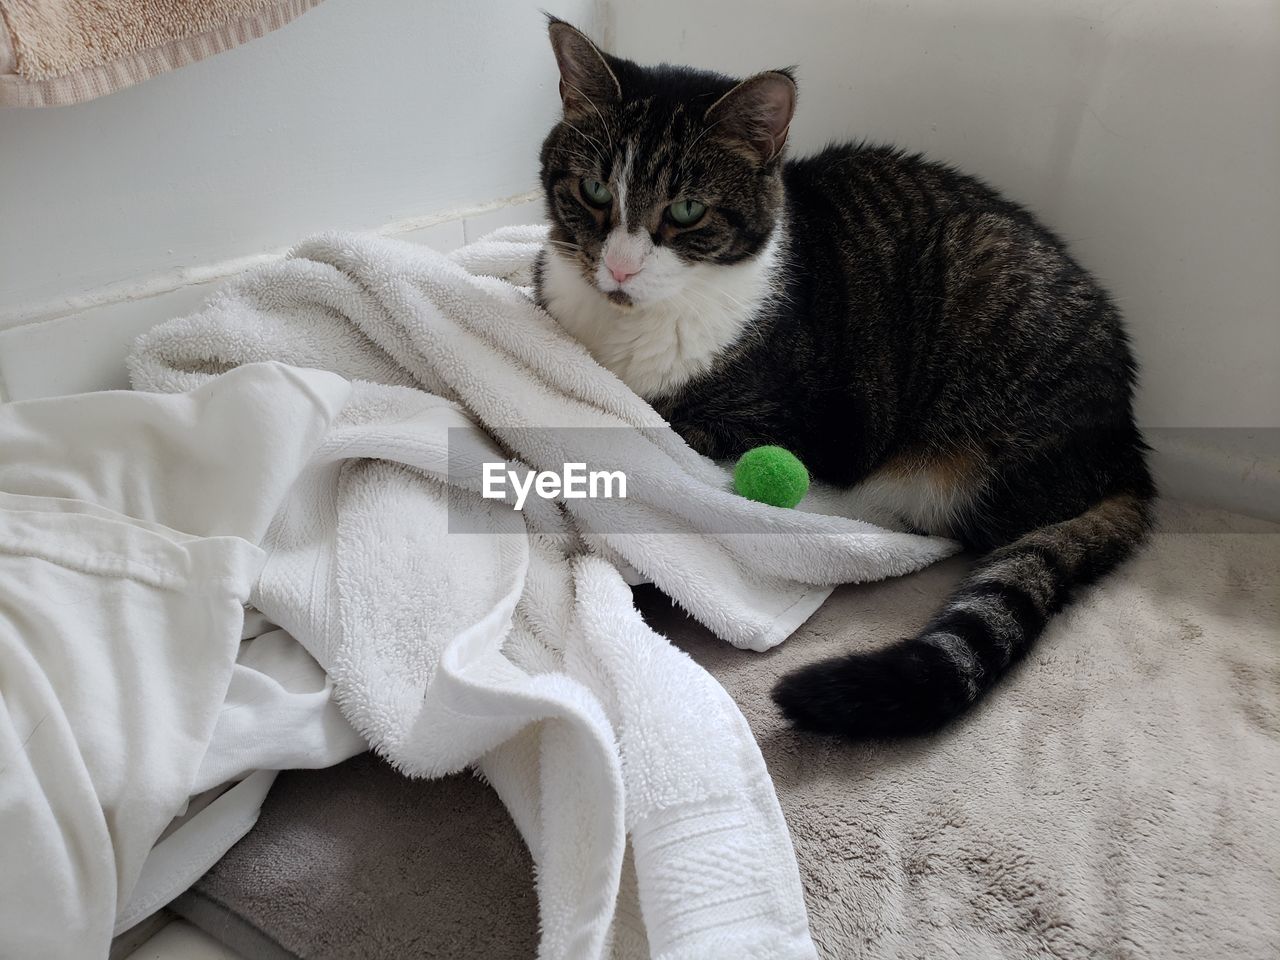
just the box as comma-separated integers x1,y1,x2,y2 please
541,18,796,308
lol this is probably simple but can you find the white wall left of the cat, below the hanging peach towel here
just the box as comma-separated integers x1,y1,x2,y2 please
0,0,594,320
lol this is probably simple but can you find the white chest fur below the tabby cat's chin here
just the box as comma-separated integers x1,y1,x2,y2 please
541,233,781,399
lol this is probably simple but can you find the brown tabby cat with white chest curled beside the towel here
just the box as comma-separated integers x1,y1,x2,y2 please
535,18,1155,739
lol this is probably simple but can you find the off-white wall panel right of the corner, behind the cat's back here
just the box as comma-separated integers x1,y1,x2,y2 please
611,0,1280,426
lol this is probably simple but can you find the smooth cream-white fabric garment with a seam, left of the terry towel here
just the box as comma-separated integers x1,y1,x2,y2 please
0,366,349,960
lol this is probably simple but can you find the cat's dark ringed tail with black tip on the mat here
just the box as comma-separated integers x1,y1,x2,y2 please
773,494,1151,739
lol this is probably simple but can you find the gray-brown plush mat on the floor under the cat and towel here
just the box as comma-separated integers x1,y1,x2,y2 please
179,507,1280,960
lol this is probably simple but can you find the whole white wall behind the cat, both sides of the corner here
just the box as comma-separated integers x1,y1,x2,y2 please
0,0,1280,426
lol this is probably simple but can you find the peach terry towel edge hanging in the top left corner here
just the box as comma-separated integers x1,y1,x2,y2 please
0,0,320,106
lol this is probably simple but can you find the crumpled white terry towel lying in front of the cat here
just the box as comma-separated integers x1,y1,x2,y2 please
131,229,954,960
